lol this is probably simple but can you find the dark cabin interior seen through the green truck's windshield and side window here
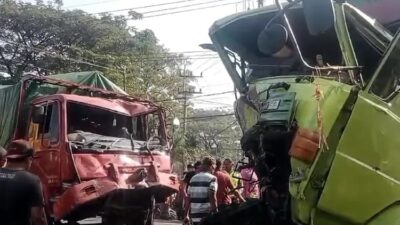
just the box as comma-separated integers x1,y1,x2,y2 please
210,2,393,87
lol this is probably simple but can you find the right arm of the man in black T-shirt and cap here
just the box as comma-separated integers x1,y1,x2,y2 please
31,180,47,225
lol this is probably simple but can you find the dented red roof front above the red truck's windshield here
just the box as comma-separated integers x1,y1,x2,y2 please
33,94,159,116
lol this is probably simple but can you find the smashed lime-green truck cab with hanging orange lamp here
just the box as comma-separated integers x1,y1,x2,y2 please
210,0,400,225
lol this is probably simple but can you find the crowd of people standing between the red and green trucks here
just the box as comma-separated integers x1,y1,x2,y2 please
178,157,259,225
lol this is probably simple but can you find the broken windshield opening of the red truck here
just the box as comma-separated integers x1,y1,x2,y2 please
67,102,165,150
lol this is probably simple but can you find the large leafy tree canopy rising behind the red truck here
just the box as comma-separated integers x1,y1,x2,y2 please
0,0,191,105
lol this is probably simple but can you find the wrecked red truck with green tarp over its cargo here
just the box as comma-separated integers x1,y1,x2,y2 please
0,72,178,225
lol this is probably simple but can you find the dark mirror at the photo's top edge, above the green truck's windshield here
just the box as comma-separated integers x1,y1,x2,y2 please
303,0,334,35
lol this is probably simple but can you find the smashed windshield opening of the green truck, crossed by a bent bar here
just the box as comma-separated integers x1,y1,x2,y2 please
216,7,343,82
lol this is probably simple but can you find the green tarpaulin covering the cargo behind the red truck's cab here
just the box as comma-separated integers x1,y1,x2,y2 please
0,71,126,146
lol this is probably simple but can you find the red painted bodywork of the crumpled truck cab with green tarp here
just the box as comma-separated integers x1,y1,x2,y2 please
10,77,178,219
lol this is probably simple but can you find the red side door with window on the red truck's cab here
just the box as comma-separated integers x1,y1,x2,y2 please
29,101,61,199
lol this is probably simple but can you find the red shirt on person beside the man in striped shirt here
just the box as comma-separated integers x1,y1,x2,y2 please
214,171,233,205
